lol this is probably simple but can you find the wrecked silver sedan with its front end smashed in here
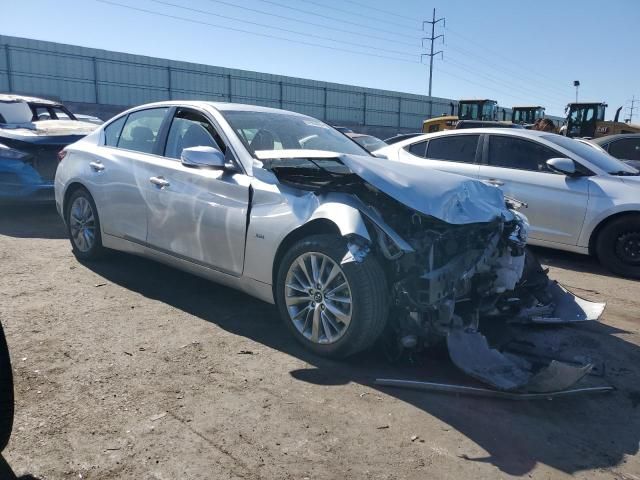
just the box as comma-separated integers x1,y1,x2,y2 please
55,102,604,391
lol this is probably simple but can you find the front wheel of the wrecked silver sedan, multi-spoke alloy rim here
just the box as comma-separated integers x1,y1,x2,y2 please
276,235,389,358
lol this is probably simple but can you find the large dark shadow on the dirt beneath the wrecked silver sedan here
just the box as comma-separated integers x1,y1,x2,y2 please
81,254,640,475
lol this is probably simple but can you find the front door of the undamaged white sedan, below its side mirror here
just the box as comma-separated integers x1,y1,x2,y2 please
479,134,589,245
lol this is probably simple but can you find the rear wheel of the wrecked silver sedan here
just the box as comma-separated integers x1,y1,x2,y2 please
64,188,105,261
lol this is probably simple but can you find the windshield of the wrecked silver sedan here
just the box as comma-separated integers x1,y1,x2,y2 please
221,110,369,157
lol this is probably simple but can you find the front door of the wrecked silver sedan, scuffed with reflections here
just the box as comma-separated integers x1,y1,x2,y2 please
144,108,250,275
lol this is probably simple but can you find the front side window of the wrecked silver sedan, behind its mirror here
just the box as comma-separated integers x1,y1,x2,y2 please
164,109,227,159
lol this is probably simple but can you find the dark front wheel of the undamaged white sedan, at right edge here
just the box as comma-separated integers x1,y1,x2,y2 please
596,215,640,278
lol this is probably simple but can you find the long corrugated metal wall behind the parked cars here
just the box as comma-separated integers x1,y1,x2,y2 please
0,35,564,131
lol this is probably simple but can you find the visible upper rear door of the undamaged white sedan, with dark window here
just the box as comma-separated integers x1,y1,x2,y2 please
400,134,482,178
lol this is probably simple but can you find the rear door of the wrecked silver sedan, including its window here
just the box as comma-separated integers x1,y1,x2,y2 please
95,107,169,243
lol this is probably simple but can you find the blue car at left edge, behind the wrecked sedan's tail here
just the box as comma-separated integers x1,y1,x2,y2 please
0,94,97,203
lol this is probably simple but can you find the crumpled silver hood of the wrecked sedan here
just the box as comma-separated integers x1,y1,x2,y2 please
256,150,513,224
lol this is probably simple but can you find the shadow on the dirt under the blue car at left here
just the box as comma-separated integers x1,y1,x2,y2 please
0,203,67,239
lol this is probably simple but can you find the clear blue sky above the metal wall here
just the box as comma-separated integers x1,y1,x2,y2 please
0,0,640,118
